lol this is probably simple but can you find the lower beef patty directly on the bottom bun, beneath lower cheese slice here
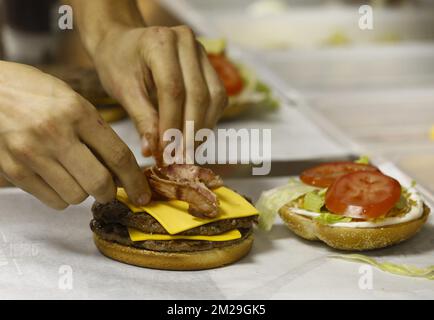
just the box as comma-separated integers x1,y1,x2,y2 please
90,219,252,252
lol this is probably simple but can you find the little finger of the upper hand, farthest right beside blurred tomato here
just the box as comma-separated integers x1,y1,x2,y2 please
199,45,228,128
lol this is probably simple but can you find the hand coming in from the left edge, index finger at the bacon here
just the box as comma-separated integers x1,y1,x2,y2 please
0,61,150,209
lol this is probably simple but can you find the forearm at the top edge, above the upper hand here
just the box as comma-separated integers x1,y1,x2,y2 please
65,0,145,57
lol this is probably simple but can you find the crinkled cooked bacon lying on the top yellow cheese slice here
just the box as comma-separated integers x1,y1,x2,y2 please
145,164,223,218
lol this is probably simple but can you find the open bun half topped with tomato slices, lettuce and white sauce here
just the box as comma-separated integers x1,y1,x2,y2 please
257,162,430,251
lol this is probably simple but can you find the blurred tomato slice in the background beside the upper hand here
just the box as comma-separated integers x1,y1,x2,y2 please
208,53,243,96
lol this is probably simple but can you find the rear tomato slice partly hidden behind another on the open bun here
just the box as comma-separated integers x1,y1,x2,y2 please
300,161,379,188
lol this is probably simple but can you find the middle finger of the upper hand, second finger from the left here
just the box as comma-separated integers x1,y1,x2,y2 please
144,28,185,150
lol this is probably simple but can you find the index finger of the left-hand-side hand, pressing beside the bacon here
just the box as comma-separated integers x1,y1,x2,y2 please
77,105,151,205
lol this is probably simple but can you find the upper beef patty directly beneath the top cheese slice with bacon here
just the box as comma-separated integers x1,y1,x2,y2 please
92,200,257,236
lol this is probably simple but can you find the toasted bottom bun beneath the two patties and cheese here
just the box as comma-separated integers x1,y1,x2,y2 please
93,234,253,270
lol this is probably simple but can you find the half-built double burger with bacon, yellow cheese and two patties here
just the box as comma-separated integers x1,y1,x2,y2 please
90,165,257,270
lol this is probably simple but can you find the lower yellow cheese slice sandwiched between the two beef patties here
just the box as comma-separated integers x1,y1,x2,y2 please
128,228,241,241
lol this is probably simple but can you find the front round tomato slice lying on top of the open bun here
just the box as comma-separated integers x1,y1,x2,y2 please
325,171,401,219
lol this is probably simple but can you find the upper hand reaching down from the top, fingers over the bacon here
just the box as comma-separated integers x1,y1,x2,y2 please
91,26,227,161
